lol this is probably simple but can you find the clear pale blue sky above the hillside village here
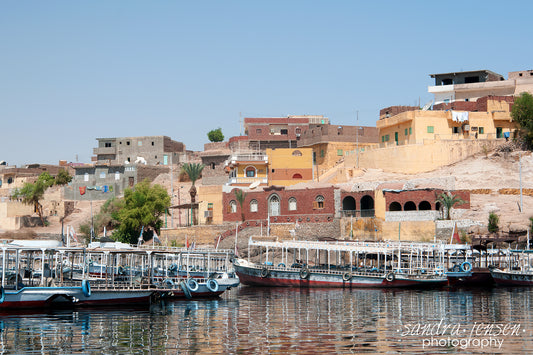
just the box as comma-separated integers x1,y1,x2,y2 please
0,0,533,165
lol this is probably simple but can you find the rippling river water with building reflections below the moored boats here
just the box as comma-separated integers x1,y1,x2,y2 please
0,286,533,354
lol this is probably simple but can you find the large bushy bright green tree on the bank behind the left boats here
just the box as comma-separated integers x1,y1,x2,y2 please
111,179,170,244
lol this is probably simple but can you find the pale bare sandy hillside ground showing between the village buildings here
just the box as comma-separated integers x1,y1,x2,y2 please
14,152,533,238
